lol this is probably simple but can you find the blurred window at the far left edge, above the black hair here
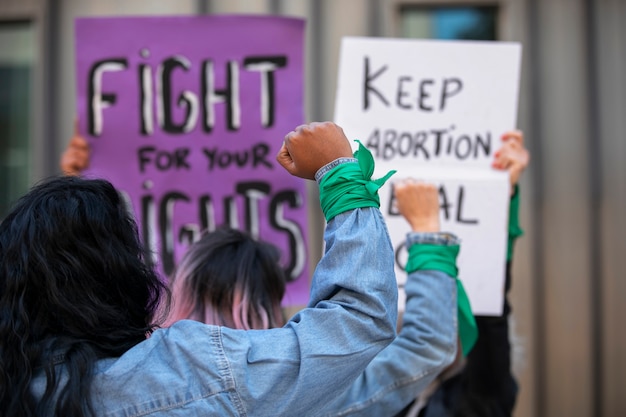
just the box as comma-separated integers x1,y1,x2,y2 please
0,22,35,219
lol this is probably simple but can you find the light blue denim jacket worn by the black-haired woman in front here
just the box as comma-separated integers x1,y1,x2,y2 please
32,208,397,417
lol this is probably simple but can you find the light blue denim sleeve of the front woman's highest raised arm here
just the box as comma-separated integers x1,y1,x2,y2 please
221,208,397,416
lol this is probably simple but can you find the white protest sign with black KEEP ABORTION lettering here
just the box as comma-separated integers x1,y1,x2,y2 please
335,38,521,315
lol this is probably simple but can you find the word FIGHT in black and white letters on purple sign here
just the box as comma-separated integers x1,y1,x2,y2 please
87,52,288,137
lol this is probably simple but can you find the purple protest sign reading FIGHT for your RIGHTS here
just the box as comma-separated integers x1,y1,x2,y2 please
75,16,308,305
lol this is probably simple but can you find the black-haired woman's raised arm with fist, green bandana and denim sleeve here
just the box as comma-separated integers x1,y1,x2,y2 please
233,123,397,416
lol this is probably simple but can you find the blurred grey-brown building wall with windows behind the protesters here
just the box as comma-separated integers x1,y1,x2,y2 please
0,0,626,417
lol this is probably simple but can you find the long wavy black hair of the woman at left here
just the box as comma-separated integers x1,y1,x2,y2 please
0,177,167,416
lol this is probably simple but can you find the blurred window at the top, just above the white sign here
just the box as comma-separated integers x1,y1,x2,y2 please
400,6,497,41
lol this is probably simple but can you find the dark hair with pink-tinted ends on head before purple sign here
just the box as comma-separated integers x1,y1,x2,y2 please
166,227,286,330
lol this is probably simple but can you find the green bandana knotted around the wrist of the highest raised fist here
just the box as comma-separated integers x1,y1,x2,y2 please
320,140,396,222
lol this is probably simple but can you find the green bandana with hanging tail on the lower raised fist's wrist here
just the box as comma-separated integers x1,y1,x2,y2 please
406,244,478,356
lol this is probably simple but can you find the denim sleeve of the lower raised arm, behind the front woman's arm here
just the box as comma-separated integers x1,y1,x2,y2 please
317,229,458,416
